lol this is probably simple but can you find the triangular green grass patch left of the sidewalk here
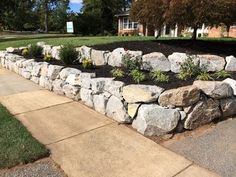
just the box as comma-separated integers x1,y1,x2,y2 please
0,104,49,169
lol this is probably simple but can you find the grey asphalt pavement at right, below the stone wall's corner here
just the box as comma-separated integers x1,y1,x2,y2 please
165,118,236,177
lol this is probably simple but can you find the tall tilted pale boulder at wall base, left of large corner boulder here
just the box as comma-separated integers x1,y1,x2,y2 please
106,96,131,123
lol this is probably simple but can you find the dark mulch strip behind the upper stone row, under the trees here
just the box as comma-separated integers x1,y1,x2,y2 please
92,40,236,57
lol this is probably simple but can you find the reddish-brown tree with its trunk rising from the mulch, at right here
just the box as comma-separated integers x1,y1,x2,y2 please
166,0,219,40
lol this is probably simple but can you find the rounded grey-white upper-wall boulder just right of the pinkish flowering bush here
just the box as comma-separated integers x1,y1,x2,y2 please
142,52,171,72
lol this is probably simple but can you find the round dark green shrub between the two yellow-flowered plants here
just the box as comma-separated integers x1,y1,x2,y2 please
59,44,79,65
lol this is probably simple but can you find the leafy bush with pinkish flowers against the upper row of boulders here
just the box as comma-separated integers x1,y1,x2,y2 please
122,53,142,71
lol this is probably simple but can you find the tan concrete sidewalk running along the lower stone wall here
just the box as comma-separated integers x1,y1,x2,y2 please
0,69,218,177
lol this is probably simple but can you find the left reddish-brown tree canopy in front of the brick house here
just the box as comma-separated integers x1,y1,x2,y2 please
130,0,168,36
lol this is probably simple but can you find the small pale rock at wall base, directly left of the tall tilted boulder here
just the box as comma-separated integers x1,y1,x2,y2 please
93,93,111,115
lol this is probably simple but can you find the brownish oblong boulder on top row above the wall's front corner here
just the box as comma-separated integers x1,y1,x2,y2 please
159,86,200,107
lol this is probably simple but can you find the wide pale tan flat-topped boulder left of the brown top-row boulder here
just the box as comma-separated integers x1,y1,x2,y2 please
122,85,164,103
